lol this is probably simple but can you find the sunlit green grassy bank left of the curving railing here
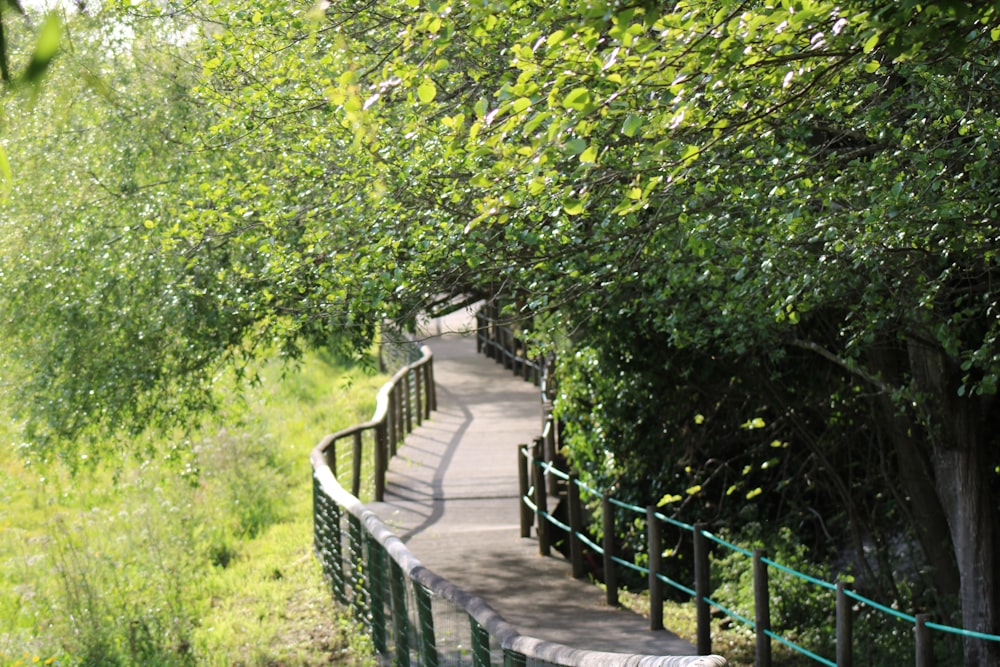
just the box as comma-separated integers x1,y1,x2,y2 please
0,355,384,667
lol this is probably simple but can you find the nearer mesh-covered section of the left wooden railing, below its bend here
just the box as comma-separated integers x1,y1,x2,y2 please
313,466,726,667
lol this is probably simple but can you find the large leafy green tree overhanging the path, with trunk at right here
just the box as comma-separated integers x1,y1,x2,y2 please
1,0,1000,664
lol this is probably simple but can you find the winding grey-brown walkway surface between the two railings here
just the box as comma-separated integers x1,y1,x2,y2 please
371,318,695,655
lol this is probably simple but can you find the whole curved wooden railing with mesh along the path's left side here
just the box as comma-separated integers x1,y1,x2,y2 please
311,340,726,667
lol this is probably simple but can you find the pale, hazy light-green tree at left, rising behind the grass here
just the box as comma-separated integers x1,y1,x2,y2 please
0,2,262,462
